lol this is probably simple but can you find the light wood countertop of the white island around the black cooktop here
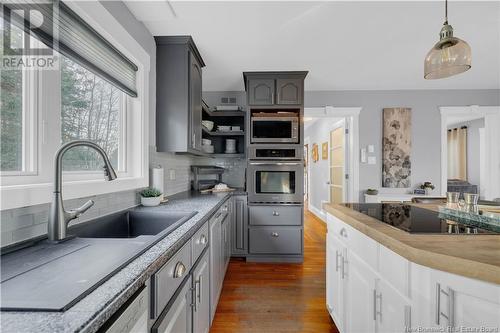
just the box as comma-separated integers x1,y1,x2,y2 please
323,204,500,284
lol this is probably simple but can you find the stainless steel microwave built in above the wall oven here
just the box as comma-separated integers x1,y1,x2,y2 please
250,113,300,143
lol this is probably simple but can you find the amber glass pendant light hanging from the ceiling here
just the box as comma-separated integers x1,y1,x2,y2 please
424,0,471,80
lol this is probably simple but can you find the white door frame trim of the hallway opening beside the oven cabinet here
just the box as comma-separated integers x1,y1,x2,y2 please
304,106,362,202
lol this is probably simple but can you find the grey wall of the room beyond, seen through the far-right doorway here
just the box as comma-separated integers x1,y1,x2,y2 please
448,118,484,193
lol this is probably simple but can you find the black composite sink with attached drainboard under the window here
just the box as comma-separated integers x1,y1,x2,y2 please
0,209,196,311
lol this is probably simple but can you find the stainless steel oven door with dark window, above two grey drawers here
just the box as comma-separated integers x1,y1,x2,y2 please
247,161,304,203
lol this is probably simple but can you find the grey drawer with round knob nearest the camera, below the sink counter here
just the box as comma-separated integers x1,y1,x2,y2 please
152,240,191,318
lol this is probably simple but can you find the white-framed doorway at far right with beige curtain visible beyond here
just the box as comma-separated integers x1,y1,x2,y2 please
440,106,500,200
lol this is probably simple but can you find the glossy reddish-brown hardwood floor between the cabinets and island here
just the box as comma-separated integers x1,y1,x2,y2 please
210,211,338,333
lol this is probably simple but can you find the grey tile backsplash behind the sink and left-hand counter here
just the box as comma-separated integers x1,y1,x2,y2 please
0,147,246,247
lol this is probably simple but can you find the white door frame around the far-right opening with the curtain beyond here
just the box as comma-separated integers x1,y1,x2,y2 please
439,105,500,200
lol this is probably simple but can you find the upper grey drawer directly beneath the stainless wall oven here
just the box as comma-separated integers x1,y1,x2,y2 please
248,205,302,225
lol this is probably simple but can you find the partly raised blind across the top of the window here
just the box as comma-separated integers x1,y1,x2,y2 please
2,0,138,97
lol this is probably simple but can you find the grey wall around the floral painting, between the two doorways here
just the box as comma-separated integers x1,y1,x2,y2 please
305,90,500,199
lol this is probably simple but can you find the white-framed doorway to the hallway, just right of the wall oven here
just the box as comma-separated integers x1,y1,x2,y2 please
304,107,361,220
